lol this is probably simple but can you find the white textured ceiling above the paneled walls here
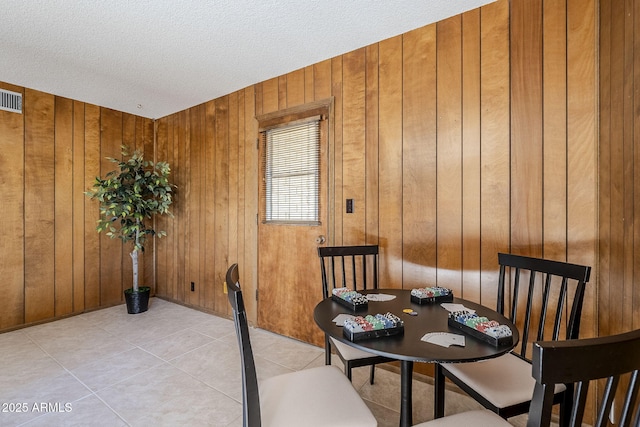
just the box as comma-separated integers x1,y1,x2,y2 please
0,0,494,118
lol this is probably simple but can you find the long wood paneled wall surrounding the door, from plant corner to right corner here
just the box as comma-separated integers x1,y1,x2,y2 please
157,0,597,342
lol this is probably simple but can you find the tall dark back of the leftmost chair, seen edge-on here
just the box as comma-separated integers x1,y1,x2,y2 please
226,264,261,427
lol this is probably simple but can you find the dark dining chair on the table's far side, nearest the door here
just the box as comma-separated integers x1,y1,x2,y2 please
318,245,394,384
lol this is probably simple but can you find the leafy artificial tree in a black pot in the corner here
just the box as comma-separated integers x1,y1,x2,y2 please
85,146,174,314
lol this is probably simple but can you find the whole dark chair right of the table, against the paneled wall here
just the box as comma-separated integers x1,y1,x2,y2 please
434,253,591,422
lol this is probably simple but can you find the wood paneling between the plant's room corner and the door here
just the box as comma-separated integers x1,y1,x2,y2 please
157,87,258,314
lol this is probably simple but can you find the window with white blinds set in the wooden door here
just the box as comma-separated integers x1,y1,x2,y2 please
262,117,320,224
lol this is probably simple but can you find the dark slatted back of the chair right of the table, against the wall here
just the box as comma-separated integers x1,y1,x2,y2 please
497,253,591,361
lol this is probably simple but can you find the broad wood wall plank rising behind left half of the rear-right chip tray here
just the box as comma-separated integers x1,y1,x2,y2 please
402,25,437,287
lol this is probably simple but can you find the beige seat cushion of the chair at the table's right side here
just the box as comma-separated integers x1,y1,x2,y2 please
442,353,566,408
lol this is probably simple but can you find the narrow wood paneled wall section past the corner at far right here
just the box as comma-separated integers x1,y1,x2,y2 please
598,0,640,335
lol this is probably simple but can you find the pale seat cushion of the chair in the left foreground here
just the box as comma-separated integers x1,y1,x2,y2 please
259,366,377,427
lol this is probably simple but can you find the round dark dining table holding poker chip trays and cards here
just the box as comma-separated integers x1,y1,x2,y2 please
313,289,519,427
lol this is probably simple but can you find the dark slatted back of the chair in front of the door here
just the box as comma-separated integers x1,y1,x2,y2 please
318,245,378,298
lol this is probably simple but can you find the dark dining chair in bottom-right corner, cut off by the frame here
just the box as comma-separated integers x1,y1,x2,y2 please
414,329,640,427
